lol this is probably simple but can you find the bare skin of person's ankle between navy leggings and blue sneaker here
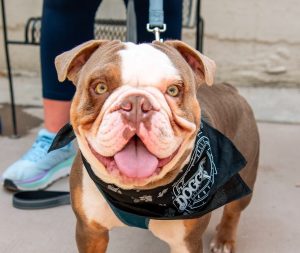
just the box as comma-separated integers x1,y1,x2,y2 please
43,98,71,133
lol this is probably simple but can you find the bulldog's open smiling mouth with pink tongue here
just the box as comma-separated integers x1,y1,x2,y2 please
89,135,178,179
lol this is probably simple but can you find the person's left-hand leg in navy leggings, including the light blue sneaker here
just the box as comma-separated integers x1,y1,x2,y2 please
2,0,101,190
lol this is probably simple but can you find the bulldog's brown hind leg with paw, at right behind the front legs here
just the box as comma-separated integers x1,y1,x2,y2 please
210,195,252,253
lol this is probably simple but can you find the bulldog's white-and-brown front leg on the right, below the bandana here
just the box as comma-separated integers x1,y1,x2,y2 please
149,214,210,253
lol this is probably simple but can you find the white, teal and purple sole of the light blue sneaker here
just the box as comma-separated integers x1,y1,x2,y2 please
3,157,74,191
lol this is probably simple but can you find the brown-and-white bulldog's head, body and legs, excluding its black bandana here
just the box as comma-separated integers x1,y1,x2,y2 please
55,40,259,253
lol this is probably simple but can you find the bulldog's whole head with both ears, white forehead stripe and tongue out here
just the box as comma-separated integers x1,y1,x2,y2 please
55,40,215,189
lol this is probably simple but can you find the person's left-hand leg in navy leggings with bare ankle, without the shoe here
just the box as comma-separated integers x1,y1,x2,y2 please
41,0,101,132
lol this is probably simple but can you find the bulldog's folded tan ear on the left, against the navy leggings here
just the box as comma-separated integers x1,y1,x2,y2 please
55,40,108,84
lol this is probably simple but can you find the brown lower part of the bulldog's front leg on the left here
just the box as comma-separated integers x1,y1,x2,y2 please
76,221,109,253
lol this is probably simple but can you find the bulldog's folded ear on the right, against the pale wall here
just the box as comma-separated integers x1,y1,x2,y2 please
164,40,216,86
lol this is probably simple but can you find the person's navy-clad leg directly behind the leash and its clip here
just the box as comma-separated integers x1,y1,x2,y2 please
134,0,182,43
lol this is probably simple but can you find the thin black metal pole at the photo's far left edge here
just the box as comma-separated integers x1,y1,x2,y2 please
1,0,18,138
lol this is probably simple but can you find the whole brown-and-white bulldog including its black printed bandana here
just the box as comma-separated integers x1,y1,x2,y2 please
55,40,259,253
